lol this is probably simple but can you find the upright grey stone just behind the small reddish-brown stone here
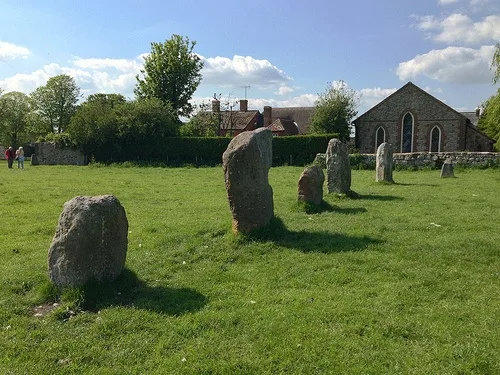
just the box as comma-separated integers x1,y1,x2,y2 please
326,138,351,194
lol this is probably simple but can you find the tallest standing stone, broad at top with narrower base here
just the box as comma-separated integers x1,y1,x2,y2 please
222,128,274,233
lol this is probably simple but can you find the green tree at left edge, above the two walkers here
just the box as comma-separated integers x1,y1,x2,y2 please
0,91,31,148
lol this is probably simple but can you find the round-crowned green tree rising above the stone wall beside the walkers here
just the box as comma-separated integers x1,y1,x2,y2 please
31,74,80,133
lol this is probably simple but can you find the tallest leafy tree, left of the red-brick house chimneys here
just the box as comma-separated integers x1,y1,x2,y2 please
134,34,203,117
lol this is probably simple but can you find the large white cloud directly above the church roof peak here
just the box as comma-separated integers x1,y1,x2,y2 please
396,46,495,84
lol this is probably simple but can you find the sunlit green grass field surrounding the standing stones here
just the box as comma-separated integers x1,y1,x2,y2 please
0,162,500,374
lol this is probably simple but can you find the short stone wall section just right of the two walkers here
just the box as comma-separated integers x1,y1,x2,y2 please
31,142,87,165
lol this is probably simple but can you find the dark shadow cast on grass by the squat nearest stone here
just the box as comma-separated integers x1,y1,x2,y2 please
82,269,207,315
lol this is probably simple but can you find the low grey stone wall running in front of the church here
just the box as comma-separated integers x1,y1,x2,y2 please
314,152,500,169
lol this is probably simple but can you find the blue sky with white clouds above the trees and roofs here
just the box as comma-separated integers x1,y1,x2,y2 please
0,0,500,114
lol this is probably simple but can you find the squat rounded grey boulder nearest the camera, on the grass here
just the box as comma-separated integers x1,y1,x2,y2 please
49,195,128,288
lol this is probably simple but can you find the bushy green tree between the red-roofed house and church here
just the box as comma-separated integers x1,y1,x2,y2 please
309,81,359,142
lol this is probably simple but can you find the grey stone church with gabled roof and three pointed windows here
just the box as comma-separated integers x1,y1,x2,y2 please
354,82,494,154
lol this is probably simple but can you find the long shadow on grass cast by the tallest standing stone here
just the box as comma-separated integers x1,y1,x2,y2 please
242,217,382,254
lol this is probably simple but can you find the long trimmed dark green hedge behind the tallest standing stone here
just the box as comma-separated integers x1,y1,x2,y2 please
87,134,336,165
